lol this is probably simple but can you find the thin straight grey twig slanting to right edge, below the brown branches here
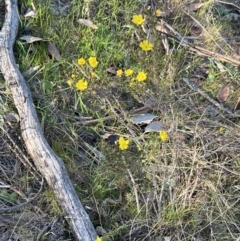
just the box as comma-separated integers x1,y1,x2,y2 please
183,78,240,118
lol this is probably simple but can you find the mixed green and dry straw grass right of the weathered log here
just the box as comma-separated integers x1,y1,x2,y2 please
0,0,240,241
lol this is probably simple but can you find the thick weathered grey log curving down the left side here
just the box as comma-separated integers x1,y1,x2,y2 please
0,0,97,241
